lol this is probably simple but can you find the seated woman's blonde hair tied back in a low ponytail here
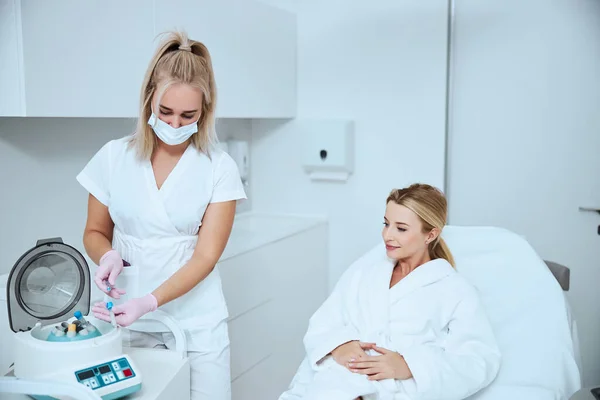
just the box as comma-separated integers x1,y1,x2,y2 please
386,183,455,267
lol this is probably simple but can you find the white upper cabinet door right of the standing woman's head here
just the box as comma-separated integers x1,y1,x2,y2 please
155,0,296,118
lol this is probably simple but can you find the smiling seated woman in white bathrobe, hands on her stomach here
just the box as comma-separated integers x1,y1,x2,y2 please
280,184,500,400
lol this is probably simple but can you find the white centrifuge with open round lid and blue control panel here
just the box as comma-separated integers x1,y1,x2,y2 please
0,238,190,400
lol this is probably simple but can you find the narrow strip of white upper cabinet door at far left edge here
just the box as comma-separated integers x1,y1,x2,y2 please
0,0,25,117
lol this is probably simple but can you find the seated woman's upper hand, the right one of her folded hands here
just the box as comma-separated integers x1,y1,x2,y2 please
348,345,412,381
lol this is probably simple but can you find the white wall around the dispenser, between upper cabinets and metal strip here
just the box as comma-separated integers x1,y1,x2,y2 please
252,0,447,285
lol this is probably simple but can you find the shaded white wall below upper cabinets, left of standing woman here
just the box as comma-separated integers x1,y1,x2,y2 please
0,118,251,274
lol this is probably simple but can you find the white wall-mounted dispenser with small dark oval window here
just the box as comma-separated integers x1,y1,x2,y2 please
302,120,354,182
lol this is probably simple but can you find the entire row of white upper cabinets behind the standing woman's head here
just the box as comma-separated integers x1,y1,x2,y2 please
0,0,296,118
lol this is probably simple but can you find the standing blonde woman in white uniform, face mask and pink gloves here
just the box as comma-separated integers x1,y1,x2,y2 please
77,33,246,400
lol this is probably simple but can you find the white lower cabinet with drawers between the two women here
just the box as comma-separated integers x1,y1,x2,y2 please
219,218,328,400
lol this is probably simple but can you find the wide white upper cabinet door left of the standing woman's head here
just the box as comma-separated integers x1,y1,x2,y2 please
21,0,154,117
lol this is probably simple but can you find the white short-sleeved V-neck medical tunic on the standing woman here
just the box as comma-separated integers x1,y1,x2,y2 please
77,137,246,338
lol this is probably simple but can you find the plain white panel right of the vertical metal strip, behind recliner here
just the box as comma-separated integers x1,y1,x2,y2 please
448,0,600,386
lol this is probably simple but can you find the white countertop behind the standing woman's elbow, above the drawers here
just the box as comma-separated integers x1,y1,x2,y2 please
220,212,327,261
